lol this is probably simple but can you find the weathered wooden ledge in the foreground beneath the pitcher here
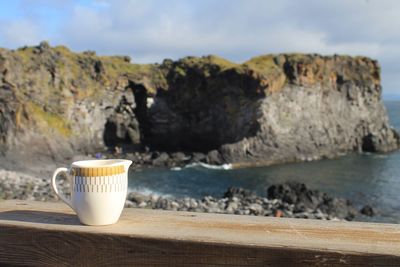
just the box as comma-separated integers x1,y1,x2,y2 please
0,201,400,266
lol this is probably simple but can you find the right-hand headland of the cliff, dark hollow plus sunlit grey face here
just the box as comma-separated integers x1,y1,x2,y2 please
143,55,399,168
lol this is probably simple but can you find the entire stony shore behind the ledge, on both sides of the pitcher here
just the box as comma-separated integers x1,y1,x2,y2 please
0,170,375,220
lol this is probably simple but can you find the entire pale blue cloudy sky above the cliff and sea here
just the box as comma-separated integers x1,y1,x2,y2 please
0,0,400,100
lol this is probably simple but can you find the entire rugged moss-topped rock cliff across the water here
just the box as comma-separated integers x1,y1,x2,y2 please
0,42,399,168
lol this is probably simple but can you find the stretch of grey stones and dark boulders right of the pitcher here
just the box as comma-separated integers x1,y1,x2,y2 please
126,183,359,221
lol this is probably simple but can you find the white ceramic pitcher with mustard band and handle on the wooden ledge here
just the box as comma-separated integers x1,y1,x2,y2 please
51,159,132,225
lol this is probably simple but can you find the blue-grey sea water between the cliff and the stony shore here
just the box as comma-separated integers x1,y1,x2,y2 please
129,101,400,223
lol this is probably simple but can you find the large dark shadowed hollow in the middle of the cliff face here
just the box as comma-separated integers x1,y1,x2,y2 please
136,68,262,153
